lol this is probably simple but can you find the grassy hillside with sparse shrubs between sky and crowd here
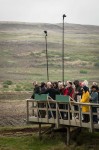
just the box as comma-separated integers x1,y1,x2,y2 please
0,22,99,91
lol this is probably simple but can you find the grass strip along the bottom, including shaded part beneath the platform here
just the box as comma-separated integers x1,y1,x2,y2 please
0,128,99,150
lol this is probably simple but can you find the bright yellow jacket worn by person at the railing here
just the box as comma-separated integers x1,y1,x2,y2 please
80,91,90,112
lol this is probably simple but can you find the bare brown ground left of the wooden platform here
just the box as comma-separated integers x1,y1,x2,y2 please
0,100,26,127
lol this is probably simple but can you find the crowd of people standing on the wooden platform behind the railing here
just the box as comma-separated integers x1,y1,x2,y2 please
31,80,99,123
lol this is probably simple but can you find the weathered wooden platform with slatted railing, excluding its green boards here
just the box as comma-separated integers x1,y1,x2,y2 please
27,95,99,132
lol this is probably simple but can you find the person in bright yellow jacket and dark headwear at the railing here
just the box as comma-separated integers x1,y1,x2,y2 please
80,86,90,122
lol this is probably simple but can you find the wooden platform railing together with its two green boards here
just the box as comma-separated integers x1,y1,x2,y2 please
27,94,99,132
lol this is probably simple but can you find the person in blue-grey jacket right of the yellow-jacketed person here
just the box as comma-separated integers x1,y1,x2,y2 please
90,85,98,123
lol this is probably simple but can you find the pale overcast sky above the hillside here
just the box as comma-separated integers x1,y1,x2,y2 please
0,0,99,25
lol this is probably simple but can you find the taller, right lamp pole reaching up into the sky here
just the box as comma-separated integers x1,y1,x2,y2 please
62,14,66,84
